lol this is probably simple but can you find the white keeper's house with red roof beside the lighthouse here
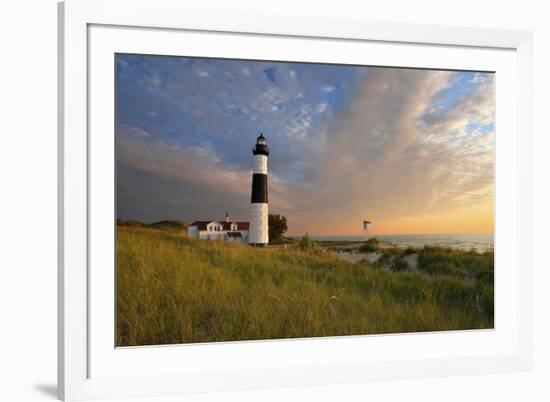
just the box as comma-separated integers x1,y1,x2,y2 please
187,214,250,243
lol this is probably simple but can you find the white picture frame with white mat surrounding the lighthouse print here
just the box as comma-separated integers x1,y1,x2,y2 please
58,0,532,400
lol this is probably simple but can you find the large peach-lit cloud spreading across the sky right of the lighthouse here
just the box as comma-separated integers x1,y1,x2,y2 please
270,69,494,233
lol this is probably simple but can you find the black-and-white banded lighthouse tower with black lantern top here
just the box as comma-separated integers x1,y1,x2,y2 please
248,134,269,247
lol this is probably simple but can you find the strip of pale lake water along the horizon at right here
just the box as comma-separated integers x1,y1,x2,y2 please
290,233,494,251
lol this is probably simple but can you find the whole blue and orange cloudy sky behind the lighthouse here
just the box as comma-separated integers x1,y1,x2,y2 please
116,54,495,235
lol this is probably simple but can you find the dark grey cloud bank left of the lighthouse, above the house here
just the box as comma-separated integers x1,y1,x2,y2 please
117,128,250,222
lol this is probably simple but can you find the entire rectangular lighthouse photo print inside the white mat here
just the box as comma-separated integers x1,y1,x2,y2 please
114,54,495,346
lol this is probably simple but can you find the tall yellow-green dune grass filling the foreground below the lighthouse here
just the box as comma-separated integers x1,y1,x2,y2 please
116,226,493,346
